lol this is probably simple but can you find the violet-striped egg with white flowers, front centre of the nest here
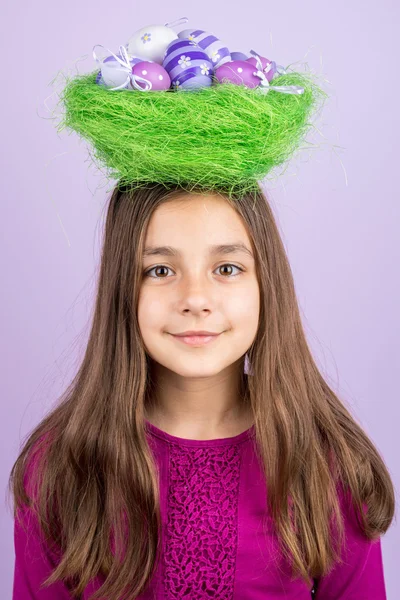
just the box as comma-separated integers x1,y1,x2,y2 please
163,39,214,89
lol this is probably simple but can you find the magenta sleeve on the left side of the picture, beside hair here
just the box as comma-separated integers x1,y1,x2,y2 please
12,438,73,600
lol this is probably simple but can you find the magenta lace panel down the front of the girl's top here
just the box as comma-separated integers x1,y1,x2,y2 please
164,444,241,600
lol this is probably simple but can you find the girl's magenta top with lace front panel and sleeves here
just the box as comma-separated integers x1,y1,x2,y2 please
13,421,386,600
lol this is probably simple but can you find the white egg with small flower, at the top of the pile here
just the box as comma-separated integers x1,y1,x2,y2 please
128,25,178,65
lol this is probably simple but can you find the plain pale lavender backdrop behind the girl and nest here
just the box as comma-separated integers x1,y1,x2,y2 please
0,0,400,600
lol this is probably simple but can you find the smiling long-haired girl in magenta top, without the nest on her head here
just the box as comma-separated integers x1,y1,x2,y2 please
11,184,394,600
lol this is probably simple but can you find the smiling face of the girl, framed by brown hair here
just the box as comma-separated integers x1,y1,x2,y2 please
138,194,259,377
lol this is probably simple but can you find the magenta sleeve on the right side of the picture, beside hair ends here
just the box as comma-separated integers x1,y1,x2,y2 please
314,490,386,600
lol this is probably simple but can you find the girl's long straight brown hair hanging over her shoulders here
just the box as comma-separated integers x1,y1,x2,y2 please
9,183,395,600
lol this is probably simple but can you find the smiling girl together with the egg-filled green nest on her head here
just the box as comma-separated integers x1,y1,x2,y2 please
10,17,395,600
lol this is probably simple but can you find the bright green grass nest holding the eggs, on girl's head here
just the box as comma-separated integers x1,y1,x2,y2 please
58,71,326,194
